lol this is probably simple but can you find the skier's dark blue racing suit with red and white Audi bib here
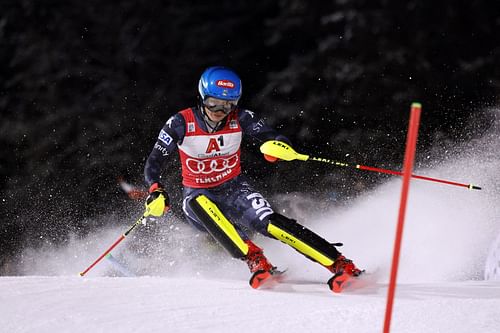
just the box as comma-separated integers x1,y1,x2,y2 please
144,107,288,239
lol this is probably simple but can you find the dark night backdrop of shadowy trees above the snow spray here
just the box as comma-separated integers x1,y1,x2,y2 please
0,0,500,273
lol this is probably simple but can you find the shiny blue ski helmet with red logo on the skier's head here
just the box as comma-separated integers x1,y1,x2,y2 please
198,66,241,101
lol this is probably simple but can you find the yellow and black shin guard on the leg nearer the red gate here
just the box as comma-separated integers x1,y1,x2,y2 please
267,213,340,266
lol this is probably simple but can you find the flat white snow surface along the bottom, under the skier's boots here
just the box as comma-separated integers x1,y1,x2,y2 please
0,276,500,332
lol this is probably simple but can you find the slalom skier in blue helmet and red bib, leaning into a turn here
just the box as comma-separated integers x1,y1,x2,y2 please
144,67,363,292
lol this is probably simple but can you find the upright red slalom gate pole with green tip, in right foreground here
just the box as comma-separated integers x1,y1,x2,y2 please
384,103,422,333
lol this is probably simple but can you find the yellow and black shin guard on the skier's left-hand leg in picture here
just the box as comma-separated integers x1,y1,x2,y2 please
187,194,248,258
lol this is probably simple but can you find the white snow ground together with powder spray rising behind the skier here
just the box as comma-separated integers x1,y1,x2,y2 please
0,108,500,332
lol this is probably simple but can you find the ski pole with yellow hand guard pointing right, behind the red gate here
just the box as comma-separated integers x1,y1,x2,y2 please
260,140,481,190
